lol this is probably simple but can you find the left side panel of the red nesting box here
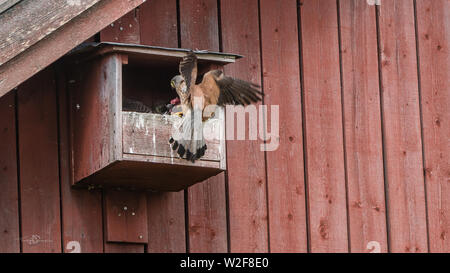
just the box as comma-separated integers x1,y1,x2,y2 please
70,54,122,183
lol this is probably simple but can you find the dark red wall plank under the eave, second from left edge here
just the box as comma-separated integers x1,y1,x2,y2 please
18,68,61,252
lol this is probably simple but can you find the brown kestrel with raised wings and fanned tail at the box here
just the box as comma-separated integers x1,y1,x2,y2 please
169,51,263,162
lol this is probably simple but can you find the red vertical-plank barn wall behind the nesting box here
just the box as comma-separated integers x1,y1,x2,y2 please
0,0,450,252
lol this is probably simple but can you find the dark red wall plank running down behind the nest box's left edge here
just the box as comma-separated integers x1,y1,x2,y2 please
57,68,103,253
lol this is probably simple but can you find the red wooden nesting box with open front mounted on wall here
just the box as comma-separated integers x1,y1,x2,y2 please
67,43,239,191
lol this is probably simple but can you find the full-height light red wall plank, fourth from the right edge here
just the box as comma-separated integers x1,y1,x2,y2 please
300,0,348,252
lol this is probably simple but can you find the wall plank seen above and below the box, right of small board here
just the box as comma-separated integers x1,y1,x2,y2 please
140,0,186,253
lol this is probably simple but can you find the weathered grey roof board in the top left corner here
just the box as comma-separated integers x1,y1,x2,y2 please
0,0,100,65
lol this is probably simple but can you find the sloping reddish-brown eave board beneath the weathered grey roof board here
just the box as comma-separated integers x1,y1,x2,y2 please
0,0,143,96
